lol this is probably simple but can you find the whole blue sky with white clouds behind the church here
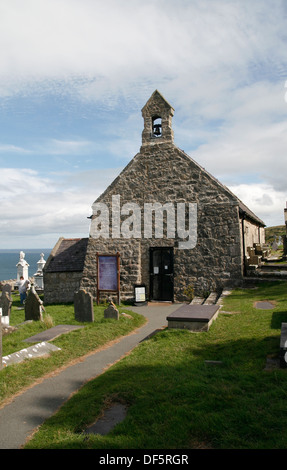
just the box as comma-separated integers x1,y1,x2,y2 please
0,0,287,249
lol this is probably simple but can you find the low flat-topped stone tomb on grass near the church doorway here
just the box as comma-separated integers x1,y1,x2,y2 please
166,304,220,331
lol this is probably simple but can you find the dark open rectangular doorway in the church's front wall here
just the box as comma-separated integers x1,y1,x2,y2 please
150,247,173,301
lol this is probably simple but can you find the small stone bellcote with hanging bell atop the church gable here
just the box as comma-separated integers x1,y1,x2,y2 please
142,90,174,146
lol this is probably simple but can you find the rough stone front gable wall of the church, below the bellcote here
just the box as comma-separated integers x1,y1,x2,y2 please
88,144,243,301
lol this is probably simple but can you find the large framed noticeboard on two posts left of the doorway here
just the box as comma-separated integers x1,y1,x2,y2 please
97,252,120,304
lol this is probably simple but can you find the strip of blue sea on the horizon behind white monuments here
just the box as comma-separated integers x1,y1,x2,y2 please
0,248,52,281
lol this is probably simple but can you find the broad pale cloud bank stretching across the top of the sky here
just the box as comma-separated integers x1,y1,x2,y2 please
0,0,286,99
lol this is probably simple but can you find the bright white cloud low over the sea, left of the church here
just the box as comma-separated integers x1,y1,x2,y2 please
0,168,119,248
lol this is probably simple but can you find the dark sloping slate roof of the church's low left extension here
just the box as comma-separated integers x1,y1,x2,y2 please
44,238,89,273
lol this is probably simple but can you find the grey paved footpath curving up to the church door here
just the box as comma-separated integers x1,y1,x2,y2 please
0,304,180,449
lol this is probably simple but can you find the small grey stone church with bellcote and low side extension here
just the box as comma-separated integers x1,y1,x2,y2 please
44,90,265,303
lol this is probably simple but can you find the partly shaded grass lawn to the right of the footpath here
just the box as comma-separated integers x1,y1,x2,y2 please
23,282,287,449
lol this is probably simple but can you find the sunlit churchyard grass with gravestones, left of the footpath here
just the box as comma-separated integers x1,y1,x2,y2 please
0,295,145,406
